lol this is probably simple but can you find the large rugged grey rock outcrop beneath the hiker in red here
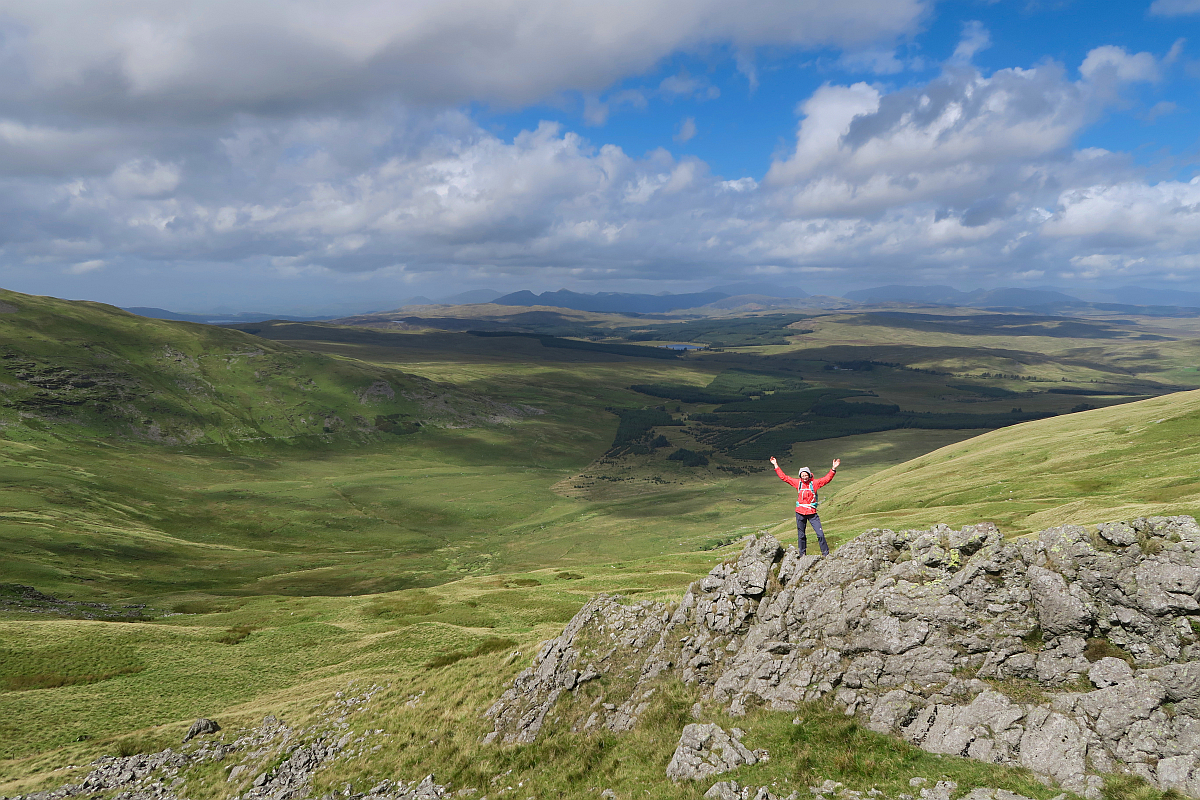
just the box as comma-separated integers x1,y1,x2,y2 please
488,517,1200,796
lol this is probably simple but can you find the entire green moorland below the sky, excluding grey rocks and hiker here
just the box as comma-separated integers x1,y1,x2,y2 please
0,293,1200,798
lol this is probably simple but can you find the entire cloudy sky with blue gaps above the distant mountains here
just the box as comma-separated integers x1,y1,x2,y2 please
0,0,1200,313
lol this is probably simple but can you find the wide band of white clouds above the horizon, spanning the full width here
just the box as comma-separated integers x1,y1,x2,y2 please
0,29,1200,302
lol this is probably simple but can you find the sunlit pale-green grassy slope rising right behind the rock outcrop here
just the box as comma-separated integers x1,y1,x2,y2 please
823,391,1200,534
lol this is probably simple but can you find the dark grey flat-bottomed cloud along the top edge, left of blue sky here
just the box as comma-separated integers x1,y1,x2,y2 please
0,0,926,119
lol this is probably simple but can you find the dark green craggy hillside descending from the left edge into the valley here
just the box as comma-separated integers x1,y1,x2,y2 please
0,291,494,449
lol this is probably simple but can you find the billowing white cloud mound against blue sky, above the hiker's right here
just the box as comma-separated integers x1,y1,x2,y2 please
767,65,1087,215
